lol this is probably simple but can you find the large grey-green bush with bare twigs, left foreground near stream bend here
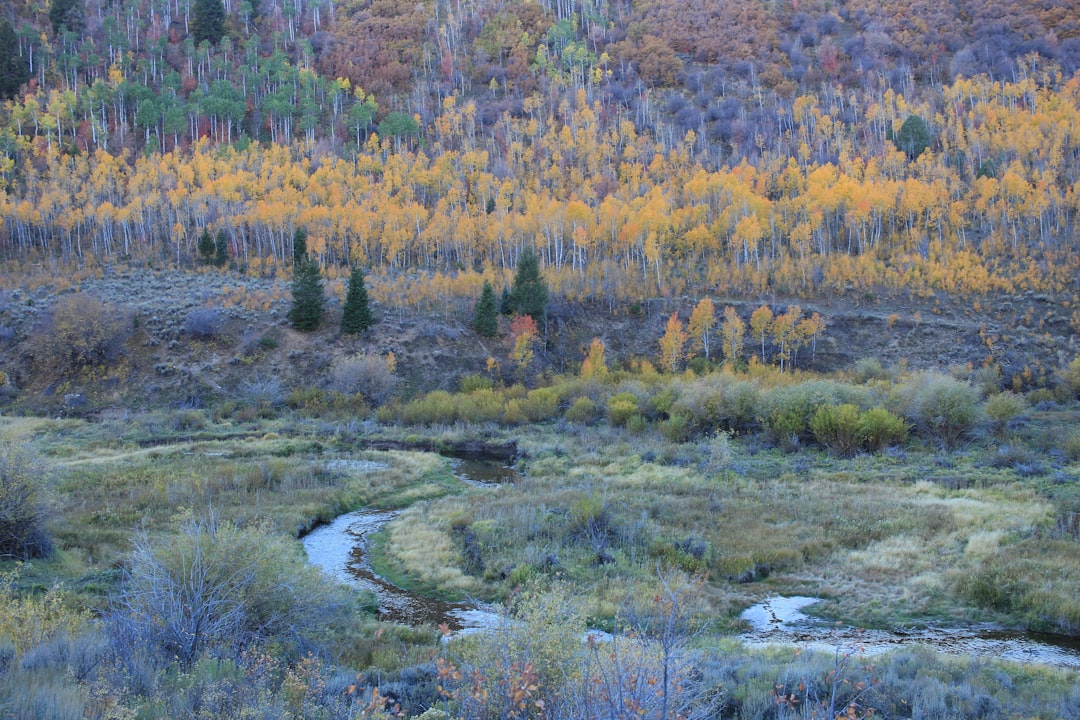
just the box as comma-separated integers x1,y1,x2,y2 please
111,520,347,667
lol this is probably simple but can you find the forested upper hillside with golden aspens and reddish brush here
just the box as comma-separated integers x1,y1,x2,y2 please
0,0,1080,299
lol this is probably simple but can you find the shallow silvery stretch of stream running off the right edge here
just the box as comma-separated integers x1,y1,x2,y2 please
740,596,1080,668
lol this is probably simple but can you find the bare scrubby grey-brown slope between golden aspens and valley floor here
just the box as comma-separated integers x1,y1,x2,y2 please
0,264,1080,416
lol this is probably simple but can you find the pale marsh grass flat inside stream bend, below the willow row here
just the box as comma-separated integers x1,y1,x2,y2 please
373,418,1076,628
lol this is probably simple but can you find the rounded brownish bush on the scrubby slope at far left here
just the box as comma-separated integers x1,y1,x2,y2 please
31,293,133,370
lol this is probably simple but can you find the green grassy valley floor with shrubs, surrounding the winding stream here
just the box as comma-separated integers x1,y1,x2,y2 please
0,368,1080,718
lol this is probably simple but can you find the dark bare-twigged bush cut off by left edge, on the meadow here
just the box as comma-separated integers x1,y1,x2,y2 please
0,444,53,560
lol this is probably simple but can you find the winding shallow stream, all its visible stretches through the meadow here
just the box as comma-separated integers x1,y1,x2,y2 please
303,459,1080,668
